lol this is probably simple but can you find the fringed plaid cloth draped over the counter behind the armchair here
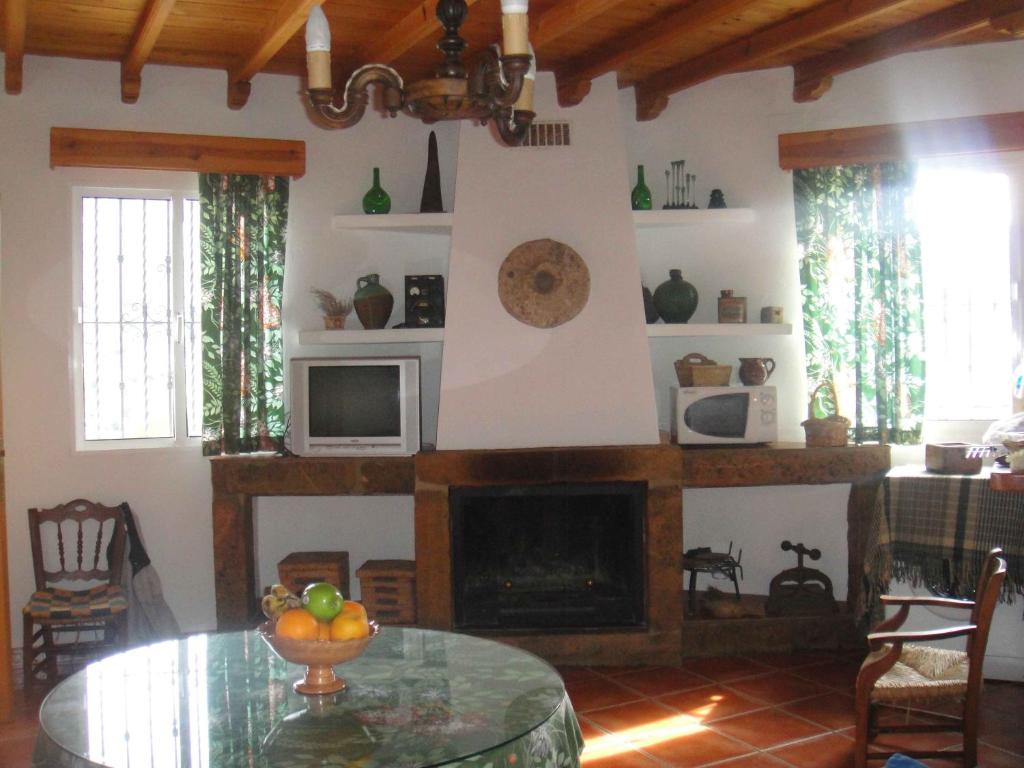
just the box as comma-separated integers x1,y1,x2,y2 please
859,468,1024,625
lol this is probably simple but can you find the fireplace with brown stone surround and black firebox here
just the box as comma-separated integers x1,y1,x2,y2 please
415,445,682,665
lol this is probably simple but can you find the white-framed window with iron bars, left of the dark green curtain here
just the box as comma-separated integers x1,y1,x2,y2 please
75,188,203,450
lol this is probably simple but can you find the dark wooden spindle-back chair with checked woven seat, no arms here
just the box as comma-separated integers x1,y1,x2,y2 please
22,499,128,691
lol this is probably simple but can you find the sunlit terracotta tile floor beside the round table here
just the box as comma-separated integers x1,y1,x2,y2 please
559,651,1024,768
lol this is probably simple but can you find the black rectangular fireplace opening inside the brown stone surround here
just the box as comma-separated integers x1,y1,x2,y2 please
449,482,646,629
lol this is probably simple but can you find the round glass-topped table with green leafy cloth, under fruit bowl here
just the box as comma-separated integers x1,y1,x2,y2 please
34,627,583,768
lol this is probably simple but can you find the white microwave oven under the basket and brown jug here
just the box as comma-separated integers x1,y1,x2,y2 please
672,386,778,445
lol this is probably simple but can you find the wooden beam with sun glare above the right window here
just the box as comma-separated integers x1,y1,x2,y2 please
778,112,1024,171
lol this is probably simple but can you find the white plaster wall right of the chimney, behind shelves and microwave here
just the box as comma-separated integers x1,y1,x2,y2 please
620,42,1024,597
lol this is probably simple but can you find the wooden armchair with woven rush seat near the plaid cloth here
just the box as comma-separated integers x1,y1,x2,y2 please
854,549,1007,768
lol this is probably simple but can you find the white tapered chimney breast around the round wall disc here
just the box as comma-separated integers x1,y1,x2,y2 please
437,73,657,450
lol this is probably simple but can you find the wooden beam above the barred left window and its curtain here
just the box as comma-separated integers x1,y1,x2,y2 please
50,127,306,178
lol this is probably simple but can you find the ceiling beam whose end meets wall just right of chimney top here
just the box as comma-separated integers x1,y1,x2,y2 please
636,0,908,121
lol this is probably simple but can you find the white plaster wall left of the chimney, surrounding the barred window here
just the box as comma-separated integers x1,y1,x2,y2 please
0,56,458,630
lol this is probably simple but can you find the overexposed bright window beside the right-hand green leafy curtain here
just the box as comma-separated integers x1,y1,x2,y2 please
914,159,1024,422
